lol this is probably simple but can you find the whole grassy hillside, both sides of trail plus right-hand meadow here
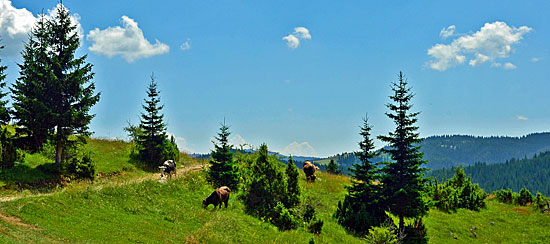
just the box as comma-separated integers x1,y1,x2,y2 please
0,140,550,243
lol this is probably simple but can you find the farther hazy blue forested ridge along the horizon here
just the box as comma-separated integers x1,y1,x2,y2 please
316,132,550,170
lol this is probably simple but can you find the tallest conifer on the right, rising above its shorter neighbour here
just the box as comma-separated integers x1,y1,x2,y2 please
378,72,428,232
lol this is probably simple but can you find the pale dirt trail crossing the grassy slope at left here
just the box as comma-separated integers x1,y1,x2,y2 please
0,165,202,204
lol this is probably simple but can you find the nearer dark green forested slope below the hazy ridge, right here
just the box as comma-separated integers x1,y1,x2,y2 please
428,152,550,196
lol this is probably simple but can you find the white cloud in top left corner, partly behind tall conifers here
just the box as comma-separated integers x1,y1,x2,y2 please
0,0,83,57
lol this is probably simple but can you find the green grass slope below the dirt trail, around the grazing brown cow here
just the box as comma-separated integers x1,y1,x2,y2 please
0,172,360,243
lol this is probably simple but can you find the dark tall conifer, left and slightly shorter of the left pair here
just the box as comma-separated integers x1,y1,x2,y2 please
10,15,55,151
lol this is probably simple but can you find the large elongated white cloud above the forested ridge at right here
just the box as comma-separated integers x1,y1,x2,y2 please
427,21,532,71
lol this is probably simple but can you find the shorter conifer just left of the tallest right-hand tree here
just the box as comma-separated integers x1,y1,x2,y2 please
335,117,386,234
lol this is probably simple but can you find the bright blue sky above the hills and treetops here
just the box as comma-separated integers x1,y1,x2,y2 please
0,0,550,156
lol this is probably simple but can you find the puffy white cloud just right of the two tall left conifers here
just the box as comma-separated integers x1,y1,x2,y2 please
87,16,170,63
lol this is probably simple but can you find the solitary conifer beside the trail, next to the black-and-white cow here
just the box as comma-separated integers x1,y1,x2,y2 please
137,75,168,169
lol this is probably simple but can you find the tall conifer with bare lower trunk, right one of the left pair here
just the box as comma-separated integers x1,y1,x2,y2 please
48,4,99,166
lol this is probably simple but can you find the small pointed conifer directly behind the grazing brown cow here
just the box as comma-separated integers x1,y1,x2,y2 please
208,120,239,189
